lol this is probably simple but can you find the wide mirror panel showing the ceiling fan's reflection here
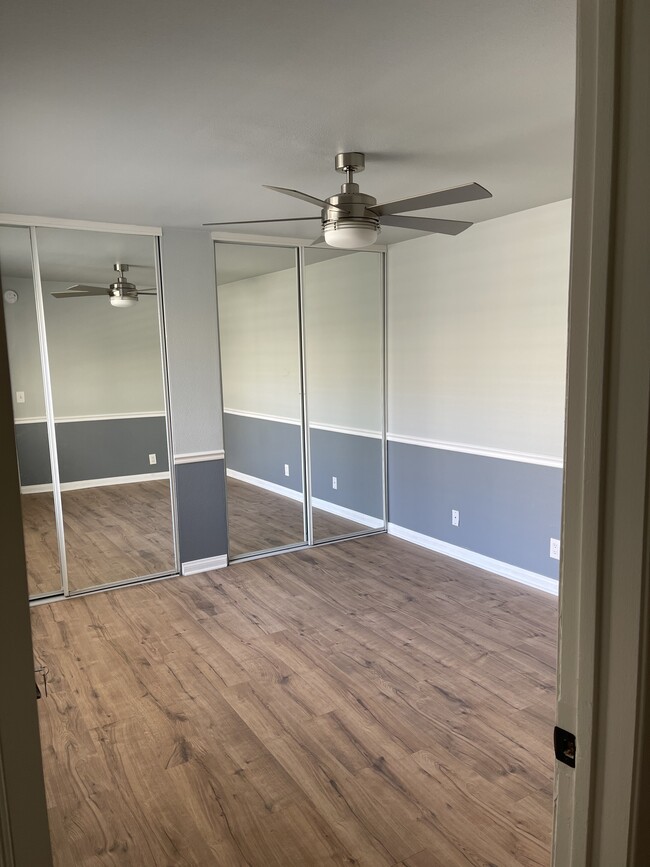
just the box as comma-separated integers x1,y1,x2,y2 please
36,229,176,592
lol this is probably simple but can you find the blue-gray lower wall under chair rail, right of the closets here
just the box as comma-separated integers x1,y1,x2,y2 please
388,442,562,579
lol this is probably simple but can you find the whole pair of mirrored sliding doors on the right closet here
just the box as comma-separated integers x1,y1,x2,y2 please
215,241,386,560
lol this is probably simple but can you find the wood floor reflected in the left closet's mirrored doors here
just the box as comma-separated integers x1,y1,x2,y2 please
21,479,175,595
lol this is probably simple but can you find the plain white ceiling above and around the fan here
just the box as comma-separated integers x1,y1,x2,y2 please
0,0,575,243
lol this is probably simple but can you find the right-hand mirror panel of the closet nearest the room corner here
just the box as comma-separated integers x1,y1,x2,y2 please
304,249,385,541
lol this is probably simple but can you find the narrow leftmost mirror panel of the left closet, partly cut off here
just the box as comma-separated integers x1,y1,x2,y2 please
0,226,62,596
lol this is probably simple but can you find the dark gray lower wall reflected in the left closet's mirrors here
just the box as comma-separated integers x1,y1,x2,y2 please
15,416,169,487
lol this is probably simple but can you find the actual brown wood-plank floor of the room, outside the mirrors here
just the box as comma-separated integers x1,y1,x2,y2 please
32,536,557,867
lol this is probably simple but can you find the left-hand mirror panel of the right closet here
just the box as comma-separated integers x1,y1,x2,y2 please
215,242,306,558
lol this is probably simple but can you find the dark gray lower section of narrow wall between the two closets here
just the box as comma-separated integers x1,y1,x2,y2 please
175,461,228,563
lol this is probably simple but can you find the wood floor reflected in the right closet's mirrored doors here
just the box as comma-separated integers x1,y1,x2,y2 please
227,476,368,557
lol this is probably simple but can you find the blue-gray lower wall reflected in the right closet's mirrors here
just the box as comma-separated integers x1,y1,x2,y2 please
224,413,384,519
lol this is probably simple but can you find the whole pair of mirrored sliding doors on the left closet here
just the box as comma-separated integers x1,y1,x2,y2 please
0,227,177,597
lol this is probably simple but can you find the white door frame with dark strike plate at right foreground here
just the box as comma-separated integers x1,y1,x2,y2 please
553,0,650,867
